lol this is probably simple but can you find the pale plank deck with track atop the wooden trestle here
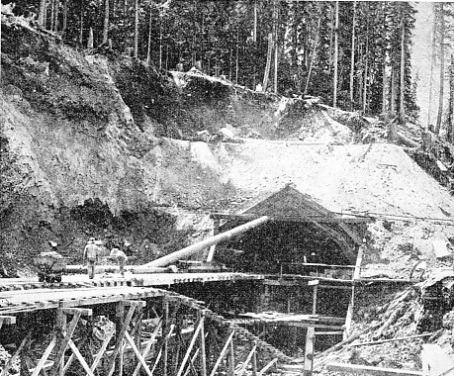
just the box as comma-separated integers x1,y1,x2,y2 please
0,273,263,315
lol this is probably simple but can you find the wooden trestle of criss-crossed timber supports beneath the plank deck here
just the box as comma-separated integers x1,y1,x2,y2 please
0,287,291,376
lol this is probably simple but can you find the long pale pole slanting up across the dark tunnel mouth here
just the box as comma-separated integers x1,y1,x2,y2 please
142,216,270,268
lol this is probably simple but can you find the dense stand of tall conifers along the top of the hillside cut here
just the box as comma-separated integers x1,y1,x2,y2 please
2,0,454,133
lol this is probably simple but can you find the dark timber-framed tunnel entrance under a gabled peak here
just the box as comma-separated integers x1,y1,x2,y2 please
208,185,366,355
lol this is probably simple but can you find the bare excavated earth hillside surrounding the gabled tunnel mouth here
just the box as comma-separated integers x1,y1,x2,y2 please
0,14,454,277
